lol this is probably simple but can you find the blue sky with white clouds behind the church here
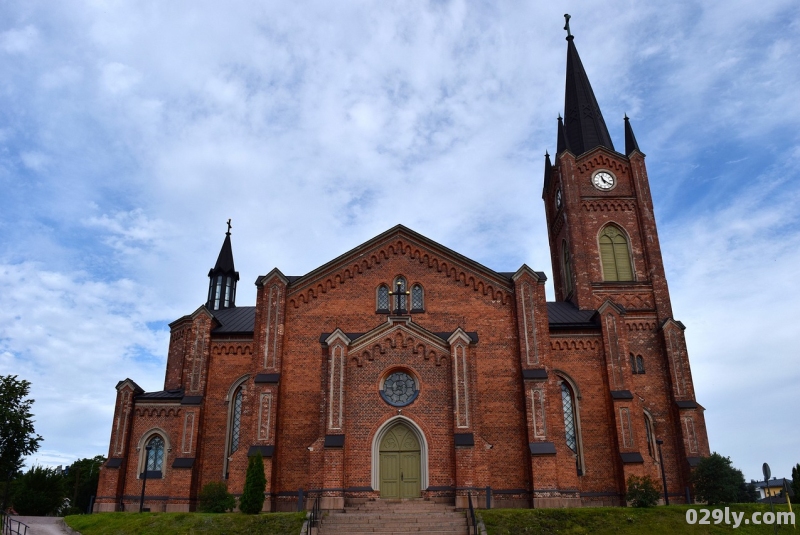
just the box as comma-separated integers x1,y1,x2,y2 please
0,0,800,484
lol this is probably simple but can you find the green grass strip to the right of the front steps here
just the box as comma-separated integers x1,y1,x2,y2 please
480,503,800,535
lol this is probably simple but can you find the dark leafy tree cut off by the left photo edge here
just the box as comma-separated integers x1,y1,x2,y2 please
0,375,42,510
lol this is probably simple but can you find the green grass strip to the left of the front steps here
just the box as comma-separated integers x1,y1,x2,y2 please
64,513,306,535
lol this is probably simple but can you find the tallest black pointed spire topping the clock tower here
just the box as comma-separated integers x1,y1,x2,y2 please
564,15,614,156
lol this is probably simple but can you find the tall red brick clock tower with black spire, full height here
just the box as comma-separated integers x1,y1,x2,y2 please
542,16,709,489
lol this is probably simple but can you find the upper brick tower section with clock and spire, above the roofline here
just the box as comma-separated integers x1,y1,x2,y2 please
542,16,672,321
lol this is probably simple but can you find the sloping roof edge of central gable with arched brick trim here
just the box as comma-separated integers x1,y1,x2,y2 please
286,225,513,291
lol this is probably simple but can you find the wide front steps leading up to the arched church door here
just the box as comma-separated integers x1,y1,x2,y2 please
319,499,467,535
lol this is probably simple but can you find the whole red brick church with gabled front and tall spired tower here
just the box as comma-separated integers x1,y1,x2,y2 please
95,27,709,511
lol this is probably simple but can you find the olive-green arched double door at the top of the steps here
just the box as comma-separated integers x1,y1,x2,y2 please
380,423,420,498
